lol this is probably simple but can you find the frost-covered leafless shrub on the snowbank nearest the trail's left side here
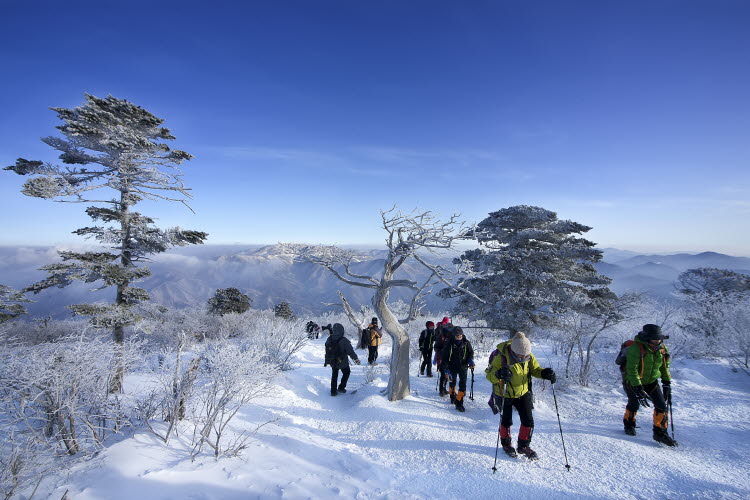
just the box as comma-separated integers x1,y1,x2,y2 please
191,340,279,457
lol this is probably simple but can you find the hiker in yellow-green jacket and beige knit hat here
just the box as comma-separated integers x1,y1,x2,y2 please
485,332,557,460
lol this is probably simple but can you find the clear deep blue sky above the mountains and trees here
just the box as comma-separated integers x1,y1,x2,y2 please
0,0,750,255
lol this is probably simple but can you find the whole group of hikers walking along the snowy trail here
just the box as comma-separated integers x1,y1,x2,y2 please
314,317,677,460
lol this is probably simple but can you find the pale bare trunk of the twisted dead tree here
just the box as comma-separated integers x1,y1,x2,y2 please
372,264,411,401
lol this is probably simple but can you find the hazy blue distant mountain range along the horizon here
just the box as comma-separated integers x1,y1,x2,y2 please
0,244,750,317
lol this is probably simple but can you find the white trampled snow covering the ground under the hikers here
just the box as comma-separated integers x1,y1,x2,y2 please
42,339,750,500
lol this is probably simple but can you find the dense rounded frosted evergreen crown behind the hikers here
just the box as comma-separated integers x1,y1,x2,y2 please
441,205,615,333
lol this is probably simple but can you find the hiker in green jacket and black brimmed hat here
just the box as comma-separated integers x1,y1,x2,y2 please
623,324,677,446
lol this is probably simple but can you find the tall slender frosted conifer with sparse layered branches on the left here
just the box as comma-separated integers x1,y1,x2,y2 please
6,94,207,389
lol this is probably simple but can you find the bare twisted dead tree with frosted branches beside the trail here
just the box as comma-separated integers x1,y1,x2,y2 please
302,207,482,401
